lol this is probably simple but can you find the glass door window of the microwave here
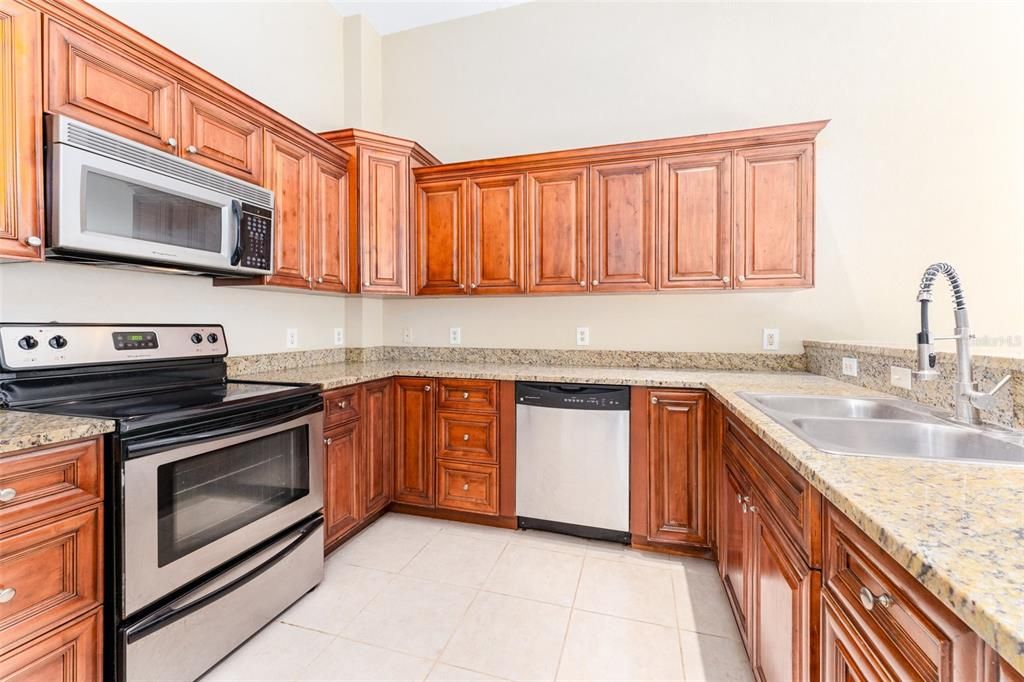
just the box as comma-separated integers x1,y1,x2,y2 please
84,171,223,253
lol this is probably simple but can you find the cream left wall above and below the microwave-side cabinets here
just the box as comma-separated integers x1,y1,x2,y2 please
0,0,352,354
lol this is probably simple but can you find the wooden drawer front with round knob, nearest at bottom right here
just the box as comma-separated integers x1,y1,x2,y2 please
822,505,984,680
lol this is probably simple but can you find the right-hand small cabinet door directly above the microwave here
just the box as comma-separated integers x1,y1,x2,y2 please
178,88,263,184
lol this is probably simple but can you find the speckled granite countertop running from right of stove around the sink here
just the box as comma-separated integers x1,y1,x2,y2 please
238,361,1024,672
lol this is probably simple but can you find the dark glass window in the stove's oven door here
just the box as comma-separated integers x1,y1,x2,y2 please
157,426,309,566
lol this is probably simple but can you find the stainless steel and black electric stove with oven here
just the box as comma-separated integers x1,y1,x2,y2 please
0,324,324,680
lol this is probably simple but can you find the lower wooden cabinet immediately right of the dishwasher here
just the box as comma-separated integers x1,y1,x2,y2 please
630,387,709,554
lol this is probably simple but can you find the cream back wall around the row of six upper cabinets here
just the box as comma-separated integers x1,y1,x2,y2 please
383,2,1024,354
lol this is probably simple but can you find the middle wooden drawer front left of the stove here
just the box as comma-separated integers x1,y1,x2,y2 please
0,507,102,650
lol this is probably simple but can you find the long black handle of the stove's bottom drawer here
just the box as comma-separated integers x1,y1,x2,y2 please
125,515,324,644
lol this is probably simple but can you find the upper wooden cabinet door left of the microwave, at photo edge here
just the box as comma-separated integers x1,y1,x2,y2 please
0,0,44,261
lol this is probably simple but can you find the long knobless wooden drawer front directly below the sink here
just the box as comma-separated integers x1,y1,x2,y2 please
722,414,821,567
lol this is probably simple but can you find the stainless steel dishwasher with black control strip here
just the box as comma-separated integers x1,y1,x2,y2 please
515,382,630,543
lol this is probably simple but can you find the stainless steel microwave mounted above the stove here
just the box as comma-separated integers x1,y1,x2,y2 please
46,116,274,276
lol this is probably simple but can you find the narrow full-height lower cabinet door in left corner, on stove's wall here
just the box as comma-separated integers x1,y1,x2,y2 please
359,379,394,517
